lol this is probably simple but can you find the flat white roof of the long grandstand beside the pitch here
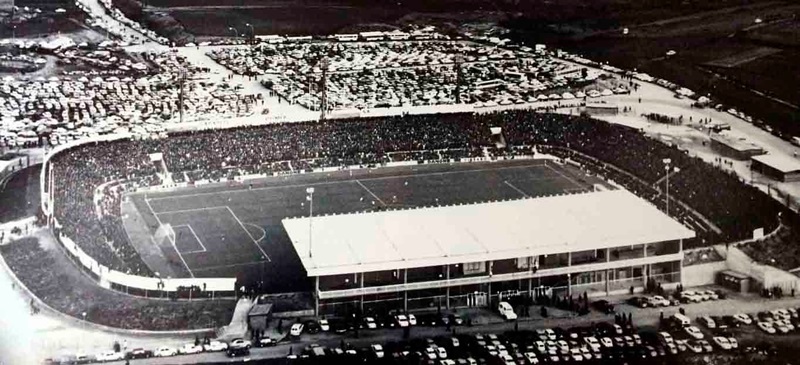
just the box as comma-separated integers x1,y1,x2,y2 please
282,189,694,276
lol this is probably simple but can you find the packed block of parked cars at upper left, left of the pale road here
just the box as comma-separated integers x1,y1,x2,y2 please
0,49,256,147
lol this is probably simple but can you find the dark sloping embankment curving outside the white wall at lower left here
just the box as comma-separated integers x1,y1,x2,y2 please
0,238,236,331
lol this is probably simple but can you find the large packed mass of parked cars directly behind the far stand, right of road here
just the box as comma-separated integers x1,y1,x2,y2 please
209,41,599,110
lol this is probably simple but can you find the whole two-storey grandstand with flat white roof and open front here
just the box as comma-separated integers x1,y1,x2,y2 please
282,190,695,315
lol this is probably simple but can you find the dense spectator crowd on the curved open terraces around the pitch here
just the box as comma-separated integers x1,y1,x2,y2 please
53,111,782,274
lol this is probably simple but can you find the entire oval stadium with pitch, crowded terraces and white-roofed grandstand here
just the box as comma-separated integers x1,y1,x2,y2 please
36,111,785,314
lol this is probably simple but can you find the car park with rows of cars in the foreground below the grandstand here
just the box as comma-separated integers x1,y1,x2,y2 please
79,290,800,365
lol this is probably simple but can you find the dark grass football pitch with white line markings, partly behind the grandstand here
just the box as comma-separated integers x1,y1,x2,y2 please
132,160,603,292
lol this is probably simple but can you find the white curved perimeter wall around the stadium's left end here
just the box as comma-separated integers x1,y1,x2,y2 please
40,134,236,298
